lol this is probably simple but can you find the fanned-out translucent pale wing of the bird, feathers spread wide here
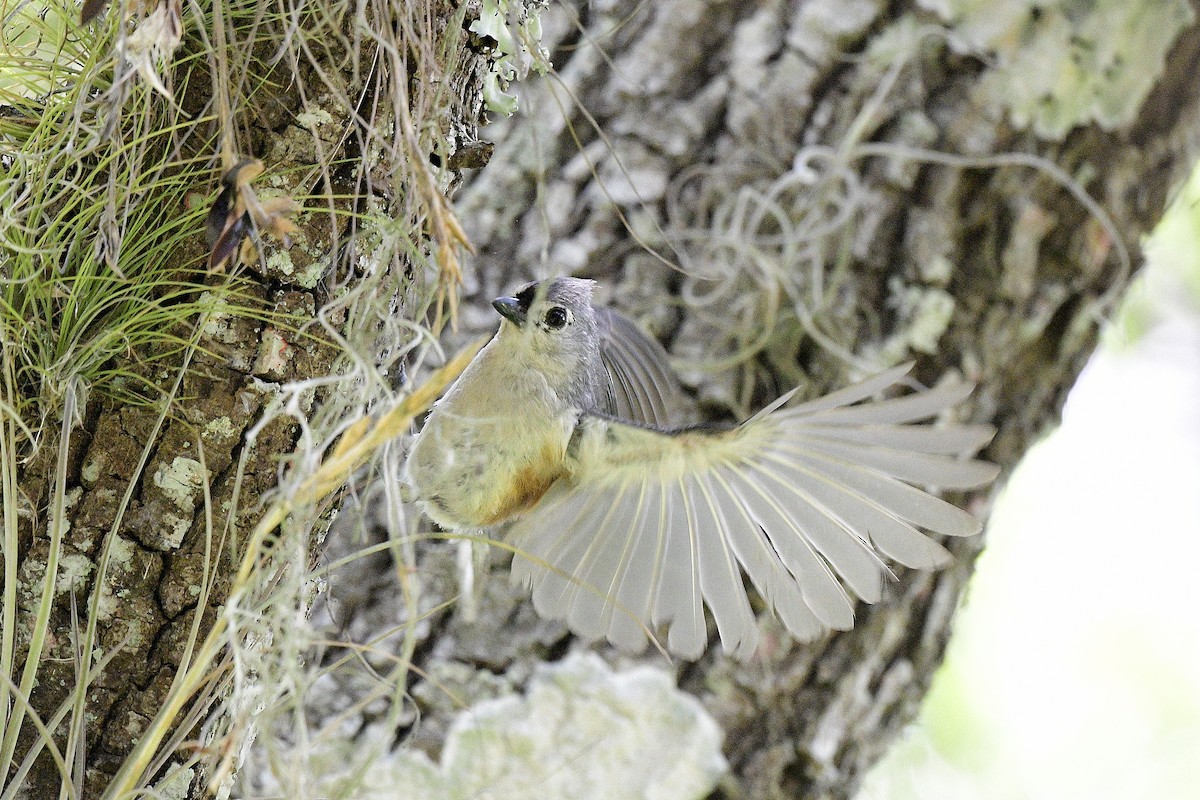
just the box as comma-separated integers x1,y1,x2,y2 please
511,367,997,658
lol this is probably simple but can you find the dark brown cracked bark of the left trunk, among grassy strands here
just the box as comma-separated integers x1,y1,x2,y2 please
5,1,490,799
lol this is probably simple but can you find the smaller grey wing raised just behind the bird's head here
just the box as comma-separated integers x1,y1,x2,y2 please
596,307,680,428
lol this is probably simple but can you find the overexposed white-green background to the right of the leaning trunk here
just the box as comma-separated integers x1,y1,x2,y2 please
859,167,1200,800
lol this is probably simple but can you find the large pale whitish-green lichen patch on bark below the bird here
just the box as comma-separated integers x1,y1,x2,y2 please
258,654,727,800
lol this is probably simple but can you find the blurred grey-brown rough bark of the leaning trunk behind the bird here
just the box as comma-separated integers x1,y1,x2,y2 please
302,0,1200,799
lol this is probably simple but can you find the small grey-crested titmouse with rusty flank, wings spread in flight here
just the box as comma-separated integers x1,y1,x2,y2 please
407,278,997,658
